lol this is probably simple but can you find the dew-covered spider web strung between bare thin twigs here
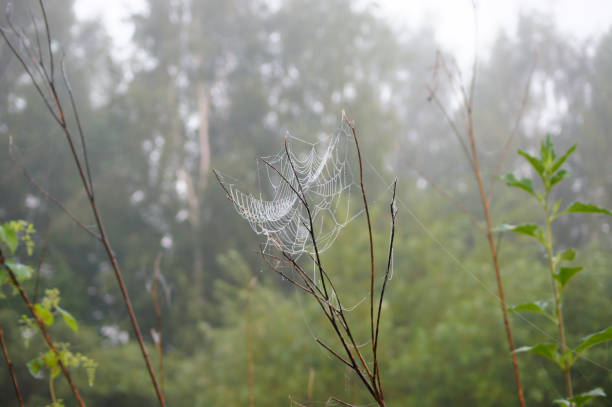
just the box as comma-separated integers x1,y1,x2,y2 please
219,116,357,258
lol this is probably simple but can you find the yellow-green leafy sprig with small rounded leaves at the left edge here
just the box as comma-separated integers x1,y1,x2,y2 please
0,220,97,407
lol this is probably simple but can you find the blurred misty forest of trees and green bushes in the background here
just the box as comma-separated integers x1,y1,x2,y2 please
0,0,612,407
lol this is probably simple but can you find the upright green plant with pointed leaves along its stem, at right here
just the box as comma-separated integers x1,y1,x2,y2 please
495,136,612,407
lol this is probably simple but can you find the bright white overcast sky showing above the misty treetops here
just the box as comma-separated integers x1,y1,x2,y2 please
75,0,612,66
